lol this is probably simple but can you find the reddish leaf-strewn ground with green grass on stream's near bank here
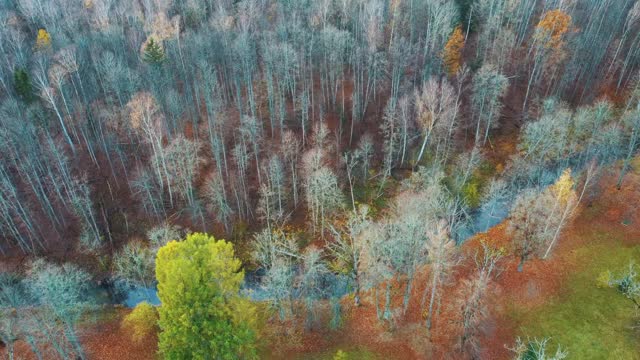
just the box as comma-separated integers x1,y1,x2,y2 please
5,158,640,360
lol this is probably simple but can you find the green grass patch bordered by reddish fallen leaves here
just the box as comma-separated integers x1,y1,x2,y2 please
513,240,640,360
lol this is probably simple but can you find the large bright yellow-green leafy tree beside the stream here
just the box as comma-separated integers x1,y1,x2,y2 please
156,233,256,359
